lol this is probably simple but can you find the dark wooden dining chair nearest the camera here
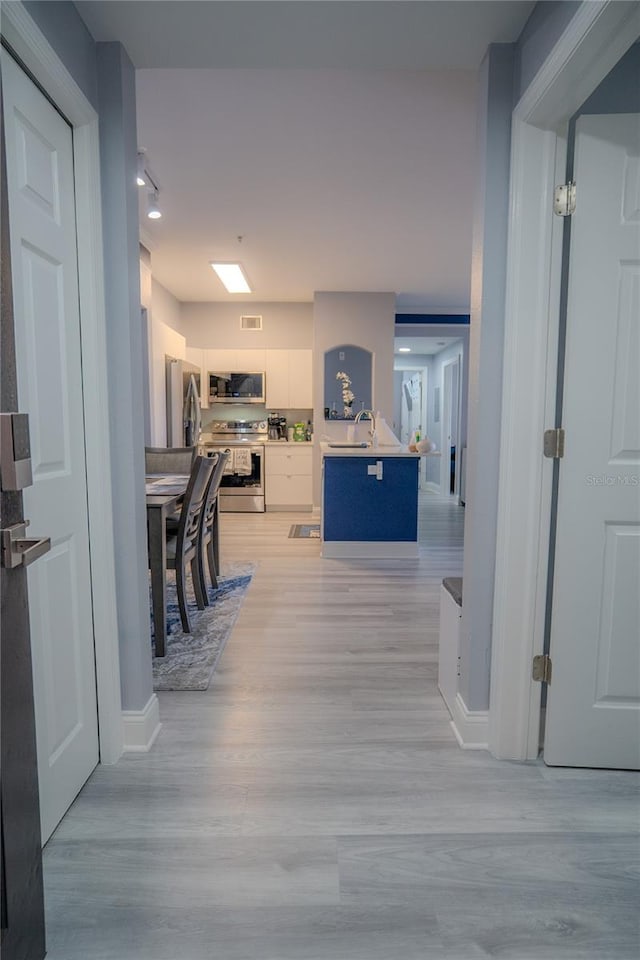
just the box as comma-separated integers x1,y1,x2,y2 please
167,457,215,633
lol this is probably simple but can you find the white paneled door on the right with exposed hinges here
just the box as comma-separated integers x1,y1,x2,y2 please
544,114,640,769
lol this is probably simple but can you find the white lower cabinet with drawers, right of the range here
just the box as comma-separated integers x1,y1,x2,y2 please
264,443,313,510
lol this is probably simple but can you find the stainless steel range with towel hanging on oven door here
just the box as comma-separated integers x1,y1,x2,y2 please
202,420,269,513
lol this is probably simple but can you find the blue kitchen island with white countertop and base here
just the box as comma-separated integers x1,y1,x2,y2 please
320,443,420,558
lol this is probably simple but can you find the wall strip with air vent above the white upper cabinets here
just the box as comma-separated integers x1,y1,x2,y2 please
180,301,313,350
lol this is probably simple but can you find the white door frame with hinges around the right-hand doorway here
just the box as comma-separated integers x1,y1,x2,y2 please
489,0,640,760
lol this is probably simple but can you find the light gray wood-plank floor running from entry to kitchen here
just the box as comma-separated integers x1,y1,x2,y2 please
45,494,640,960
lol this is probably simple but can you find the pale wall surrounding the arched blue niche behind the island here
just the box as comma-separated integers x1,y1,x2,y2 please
313,292,396,506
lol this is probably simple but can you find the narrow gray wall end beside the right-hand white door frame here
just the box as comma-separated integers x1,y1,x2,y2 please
459,44,515,710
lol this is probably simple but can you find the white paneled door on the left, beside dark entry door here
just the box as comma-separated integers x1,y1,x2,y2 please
2,51,98,842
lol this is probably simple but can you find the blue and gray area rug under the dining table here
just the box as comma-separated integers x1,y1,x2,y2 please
151,563,256,690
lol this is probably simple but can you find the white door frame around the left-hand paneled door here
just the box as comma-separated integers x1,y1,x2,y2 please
2,2,123,763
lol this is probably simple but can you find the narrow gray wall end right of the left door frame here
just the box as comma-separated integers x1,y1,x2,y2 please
97,43,153,710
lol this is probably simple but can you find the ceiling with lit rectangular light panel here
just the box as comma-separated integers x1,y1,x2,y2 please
76,0,534,312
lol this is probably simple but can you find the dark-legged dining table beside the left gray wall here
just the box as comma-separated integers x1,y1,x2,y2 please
145,473,189,657
